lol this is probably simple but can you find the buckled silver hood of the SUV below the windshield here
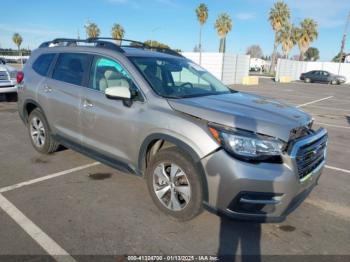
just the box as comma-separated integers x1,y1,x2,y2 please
168,92,311,141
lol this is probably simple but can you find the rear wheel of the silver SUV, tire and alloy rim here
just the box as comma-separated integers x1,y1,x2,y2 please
28,108,59,154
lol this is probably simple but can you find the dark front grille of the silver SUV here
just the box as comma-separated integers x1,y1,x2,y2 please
295,135,327,179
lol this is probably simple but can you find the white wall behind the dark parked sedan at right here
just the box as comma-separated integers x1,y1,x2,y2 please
276,59,350,83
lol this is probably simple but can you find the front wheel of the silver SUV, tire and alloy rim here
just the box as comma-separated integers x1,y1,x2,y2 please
146,147,203,221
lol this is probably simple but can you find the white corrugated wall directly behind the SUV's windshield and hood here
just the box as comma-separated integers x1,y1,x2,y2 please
182,52,250,85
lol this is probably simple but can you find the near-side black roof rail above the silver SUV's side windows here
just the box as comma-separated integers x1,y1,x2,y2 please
39,38,125,53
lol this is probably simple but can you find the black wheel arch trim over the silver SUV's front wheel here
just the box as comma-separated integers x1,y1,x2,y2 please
137,133,209,201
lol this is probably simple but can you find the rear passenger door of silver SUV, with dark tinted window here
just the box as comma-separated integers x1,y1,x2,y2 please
42,53,92,143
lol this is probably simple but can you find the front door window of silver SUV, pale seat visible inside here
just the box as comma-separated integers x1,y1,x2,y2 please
89,57,136,92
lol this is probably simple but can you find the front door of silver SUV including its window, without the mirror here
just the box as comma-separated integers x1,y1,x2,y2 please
81,56,145,166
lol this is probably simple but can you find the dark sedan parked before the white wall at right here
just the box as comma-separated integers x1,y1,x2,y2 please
300,70,346,85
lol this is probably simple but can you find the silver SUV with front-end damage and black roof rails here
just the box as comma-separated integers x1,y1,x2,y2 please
18,38,327,221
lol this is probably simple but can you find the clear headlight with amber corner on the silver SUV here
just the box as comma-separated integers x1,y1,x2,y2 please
209,126,284,163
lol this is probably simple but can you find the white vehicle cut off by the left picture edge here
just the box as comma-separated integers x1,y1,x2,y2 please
0,58,17,101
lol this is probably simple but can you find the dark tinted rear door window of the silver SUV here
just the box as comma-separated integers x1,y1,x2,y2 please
52,53,90,85
